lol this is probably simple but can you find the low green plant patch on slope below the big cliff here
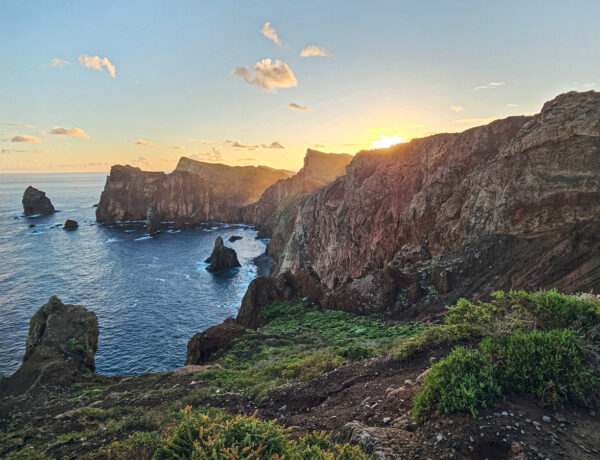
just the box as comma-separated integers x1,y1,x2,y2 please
198,301,425,397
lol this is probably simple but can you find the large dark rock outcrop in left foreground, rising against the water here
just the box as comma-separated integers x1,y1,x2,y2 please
0,296,98,393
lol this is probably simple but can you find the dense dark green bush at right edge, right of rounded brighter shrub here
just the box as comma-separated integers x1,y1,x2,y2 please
480,329,598,407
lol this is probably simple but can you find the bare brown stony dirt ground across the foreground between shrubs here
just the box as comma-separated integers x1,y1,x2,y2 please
0,350,600,460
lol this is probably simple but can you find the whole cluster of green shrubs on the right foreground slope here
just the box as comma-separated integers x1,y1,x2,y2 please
412,290,600,419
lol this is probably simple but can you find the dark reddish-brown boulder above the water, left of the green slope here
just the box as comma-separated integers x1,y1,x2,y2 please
185,318,246,366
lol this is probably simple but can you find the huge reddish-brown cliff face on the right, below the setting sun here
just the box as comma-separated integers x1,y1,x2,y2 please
273,92,600,318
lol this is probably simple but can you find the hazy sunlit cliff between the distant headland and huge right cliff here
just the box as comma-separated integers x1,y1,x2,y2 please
231,149,353,244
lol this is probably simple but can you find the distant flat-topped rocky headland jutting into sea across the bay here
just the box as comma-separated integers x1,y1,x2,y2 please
96,157,293,225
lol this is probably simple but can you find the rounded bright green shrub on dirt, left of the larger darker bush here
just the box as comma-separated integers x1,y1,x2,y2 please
413,347,502,420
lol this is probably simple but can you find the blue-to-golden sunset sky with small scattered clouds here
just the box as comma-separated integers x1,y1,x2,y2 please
0,0,600,173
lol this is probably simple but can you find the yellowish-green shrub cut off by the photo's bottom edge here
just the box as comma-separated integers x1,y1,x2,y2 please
154,407,367,460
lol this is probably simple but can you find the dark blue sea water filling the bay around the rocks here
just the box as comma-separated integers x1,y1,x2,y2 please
0,173,268,375
